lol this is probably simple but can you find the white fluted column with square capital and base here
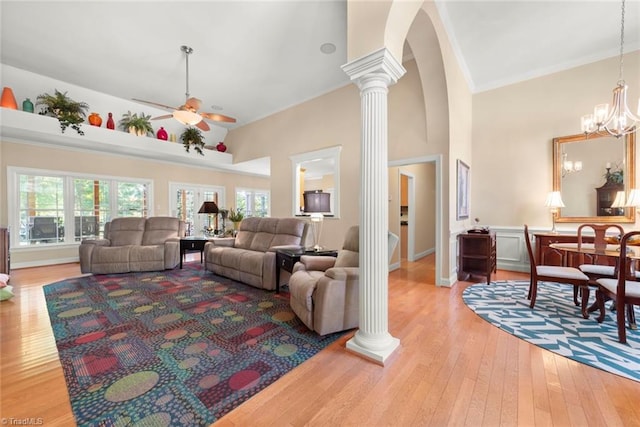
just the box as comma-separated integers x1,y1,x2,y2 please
342,48,406,364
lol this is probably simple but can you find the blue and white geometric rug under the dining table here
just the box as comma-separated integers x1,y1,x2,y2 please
462,281,640,382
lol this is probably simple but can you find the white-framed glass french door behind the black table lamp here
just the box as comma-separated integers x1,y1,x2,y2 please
169,182,226,236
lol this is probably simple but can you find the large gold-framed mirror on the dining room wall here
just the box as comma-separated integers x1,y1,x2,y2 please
553,132,636,223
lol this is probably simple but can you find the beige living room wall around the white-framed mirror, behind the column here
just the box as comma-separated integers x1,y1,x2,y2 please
225,56,428,248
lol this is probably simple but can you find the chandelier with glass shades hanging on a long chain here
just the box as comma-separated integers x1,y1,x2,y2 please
581,0,640,138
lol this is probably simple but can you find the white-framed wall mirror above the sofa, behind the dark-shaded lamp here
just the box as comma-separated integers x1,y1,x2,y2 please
289,146,342,217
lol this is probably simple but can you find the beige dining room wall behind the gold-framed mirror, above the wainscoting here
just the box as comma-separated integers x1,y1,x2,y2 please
471,51,640,229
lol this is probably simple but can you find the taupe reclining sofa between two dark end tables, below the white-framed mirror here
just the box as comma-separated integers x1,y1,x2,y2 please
204,218,308,290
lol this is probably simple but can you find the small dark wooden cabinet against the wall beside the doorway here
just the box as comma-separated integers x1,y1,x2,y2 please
458,231,496,285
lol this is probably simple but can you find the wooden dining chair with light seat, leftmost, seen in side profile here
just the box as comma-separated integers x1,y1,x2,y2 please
524,224,589,319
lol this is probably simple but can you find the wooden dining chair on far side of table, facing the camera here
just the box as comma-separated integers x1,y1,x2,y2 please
578,224,624,286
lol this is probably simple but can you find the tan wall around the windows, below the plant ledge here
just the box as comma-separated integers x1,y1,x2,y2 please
0,142,270,265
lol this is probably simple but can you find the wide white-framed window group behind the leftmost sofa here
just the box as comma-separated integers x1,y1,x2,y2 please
7,167,151,247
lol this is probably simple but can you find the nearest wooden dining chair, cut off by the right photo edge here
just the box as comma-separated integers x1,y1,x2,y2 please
596,231,640,344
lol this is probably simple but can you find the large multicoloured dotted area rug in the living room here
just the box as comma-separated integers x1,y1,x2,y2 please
44,263,341,426
